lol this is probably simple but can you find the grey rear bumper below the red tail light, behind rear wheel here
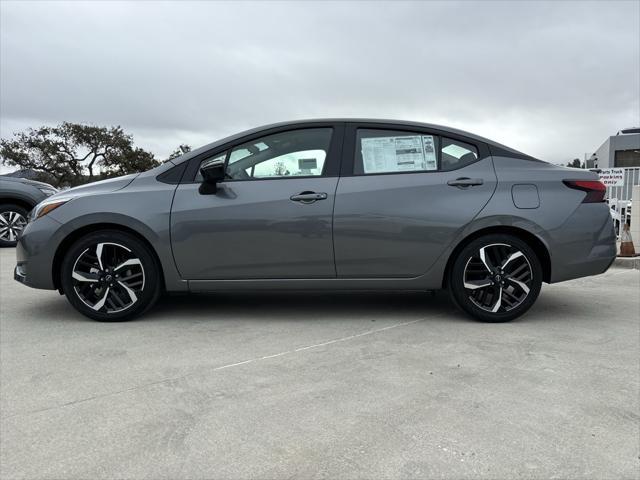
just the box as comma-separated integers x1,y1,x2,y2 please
550,203,616,283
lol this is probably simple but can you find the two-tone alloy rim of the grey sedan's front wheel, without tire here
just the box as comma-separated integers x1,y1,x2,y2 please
71,242,145,313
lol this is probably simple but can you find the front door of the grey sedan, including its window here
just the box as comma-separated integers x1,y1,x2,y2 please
171,126,341,280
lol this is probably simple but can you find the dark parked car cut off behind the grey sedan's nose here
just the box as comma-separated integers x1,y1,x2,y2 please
0,176,58,247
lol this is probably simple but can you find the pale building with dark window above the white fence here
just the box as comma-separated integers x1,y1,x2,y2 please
587,127,640,168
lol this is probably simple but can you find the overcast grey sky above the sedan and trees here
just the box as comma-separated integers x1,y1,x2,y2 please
0,0,640,163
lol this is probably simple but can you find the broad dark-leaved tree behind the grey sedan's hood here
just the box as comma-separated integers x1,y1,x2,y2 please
0,122,159,187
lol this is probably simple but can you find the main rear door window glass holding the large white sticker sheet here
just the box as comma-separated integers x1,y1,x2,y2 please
353,129,438,175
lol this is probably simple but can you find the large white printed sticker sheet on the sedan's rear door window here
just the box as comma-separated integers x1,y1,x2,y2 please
362,135,437,173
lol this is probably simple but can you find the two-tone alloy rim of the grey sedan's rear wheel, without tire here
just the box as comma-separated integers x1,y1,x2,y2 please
464,243,533,313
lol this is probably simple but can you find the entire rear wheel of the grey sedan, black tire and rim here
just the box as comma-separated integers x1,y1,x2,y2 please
448,234,542,323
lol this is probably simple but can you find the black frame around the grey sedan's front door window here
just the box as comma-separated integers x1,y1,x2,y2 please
180,122,345,185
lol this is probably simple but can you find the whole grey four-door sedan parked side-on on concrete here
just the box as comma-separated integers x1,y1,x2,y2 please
15,120,616,322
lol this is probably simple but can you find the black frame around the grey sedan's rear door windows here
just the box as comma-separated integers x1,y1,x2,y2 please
340,122,491,177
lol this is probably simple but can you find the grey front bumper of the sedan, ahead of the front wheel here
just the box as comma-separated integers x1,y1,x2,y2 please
13,216,64,290
